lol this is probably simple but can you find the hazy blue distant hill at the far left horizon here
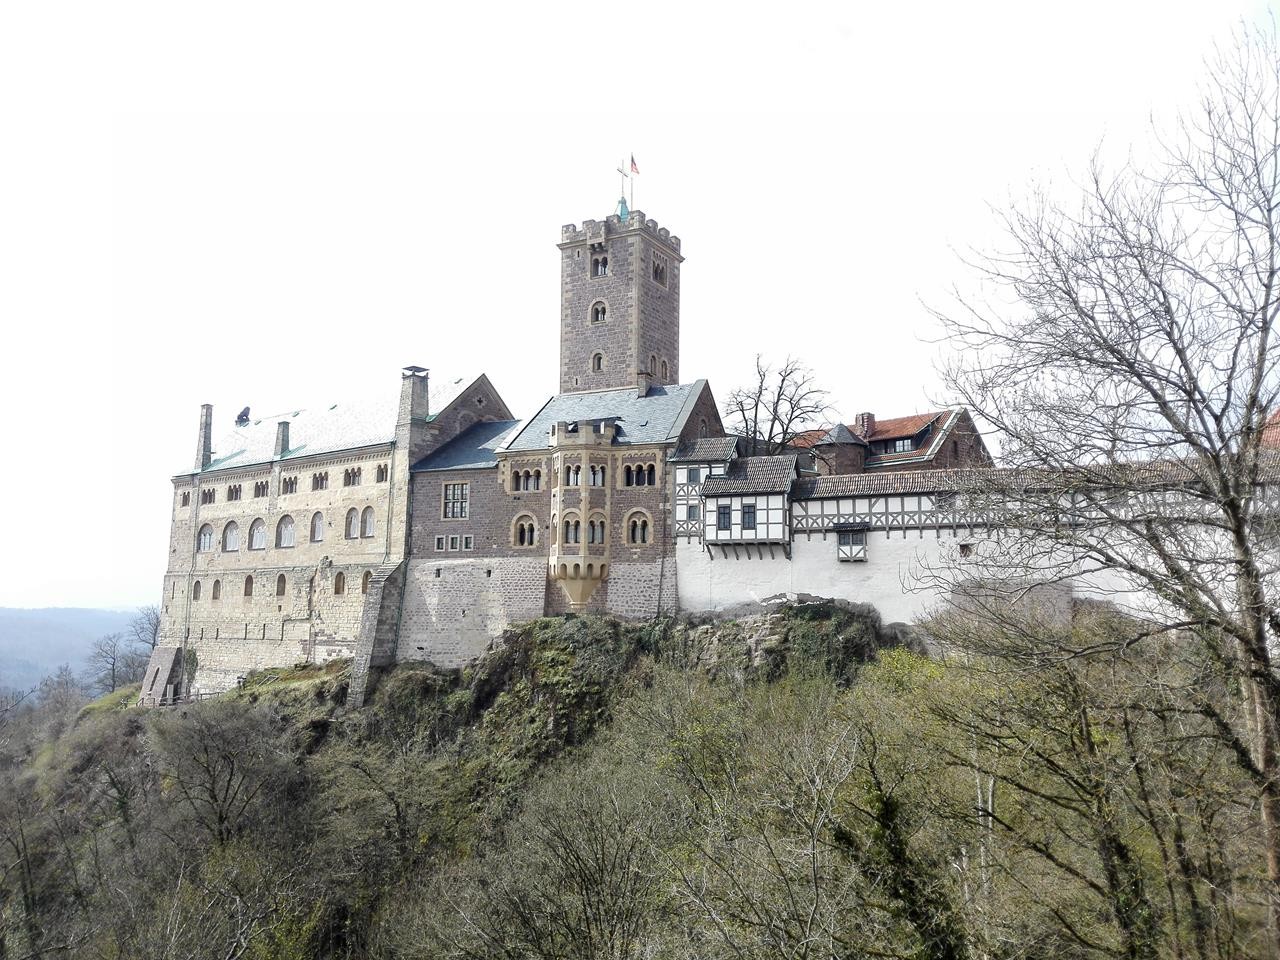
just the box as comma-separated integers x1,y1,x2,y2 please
0,607,134,687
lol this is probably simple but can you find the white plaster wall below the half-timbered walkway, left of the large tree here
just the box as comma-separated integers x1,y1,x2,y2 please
676,530,970,622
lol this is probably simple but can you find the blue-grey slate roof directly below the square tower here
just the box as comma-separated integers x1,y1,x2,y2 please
504,380,707,451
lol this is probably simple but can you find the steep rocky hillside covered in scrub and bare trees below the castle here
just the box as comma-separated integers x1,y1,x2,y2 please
0,604,1262,960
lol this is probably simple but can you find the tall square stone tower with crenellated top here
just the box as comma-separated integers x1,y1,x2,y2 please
558,204,684,396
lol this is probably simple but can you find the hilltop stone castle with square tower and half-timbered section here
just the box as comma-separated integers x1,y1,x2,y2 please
143,202,991,704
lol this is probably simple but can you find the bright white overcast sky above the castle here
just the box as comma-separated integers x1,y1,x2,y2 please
0,0,1268,607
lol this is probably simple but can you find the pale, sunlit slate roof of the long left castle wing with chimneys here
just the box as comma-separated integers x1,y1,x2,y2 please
183,376,476,474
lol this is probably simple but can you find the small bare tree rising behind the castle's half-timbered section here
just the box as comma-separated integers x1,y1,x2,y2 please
724,355,831,456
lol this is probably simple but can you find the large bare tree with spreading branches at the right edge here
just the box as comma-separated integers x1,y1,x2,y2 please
940,24,1280,948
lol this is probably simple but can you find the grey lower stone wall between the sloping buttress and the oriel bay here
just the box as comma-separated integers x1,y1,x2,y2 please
396,557,547,667
